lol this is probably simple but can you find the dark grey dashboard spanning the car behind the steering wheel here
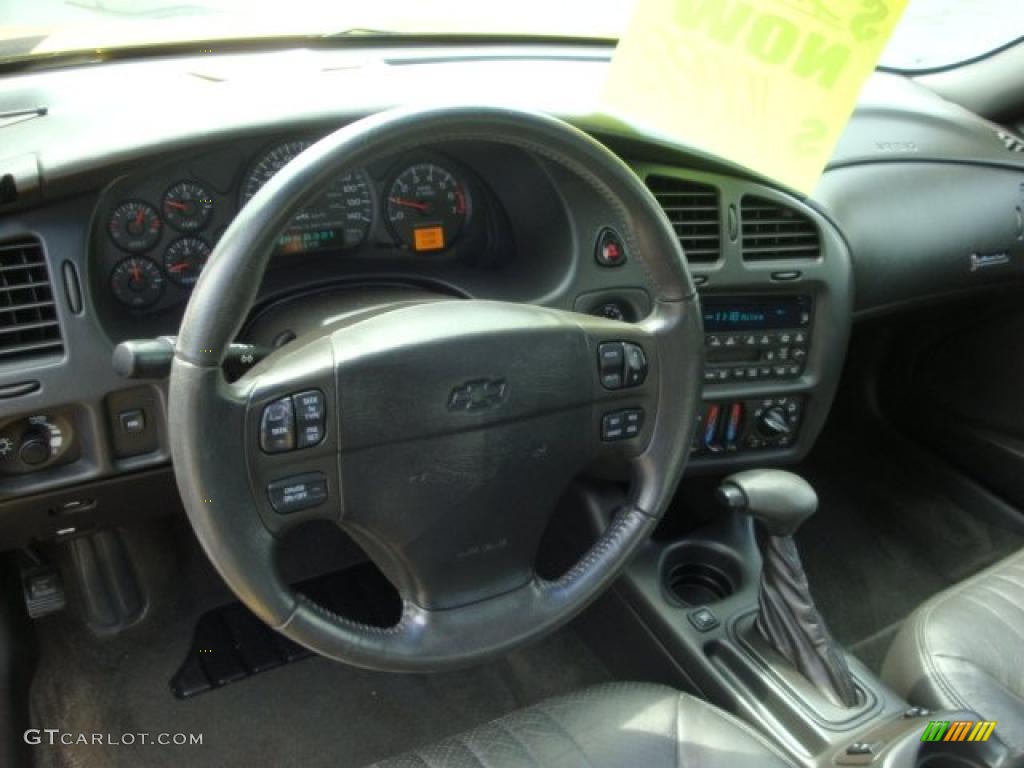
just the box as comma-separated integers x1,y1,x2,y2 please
0,46,1024,547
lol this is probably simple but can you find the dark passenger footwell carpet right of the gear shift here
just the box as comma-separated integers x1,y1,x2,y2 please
797,422,1024,671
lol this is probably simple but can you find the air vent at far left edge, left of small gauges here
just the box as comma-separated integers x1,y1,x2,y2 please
0,239,63,362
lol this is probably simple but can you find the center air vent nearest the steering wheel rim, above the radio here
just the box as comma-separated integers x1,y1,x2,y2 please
647,176,722,264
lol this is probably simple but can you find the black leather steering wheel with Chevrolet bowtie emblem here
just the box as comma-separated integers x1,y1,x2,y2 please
169,108,702,671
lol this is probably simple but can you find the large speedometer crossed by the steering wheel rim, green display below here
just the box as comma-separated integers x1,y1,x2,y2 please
241,140,374,253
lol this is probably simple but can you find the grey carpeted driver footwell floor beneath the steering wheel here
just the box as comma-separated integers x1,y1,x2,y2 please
30,520,609,768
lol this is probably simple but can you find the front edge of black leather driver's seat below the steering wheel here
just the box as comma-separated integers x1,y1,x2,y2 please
368,683,793,768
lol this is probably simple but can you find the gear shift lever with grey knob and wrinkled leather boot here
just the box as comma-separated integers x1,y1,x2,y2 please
718,469,857,707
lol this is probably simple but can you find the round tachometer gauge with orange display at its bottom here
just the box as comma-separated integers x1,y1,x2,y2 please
387,163,469,252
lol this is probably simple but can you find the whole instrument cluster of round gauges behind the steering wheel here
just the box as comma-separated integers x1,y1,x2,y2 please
100,139,472,312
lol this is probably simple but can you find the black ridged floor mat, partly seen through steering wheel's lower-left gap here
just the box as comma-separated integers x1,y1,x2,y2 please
171,563,401,698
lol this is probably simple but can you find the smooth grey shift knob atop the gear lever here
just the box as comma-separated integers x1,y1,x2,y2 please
718,469,818,536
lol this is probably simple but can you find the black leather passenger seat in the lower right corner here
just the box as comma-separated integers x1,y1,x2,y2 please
882,550,1024,755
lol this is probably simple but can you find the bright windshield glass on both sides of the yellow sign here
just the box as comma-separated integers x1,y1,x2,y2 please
0,0,1024,70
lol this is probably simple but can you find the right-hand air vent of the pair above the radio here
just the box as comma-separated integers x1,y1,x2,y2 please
740,196,821,261
